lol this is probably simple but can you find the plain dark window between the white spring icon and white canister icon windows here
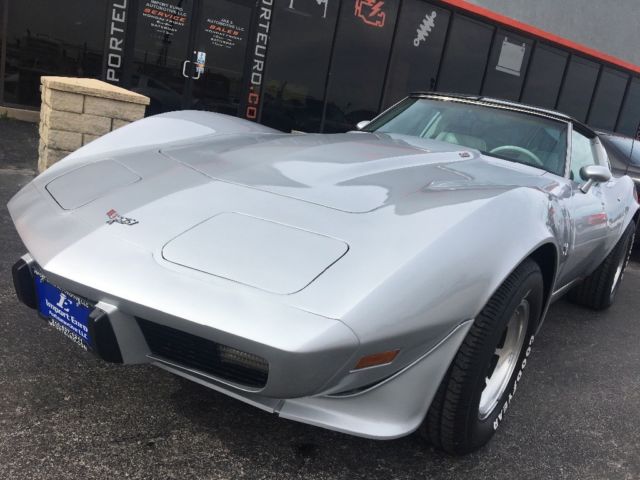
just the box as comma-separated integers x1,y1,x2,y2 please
437,15,494,95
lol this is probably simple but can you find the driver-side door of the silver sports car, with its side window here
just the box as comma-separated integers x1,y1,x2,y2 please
558,130,615,286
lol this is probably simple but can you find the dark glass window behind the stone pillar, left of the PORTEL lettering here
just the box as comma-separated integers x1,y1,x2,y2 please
3,0,107,107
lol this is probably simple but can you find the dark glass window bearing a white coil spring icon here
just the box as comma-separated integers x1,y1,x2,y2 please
383,0,451,108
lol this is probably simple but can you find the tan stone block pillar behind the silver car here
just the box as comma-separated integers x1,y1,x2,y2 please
38,77,150,172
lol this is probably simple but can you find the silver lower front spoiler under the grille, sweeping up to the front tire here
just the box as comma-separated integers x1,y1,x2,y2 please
132,320,473,440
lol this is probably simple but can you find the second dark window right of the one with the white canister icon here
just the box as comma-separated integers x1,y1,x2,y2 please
558,56,600,122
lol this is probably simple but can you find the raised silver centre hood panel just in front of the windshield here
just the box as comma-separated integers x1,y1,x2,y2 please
161,132,552,213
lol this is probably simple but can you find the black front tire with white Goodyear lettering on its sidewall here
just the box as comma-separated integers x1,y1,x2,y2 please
420,260,544,454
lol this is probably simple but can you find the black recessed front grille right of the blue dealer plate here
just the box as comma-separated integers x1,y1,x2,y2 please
136,318,269,388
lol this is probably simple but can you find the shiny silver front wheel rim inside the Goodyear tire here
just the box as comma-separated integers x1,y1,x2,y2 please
478,297,530,420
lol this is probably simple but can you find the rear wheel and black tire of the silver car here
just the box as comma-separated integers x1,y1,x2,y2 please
568,222,636,310
